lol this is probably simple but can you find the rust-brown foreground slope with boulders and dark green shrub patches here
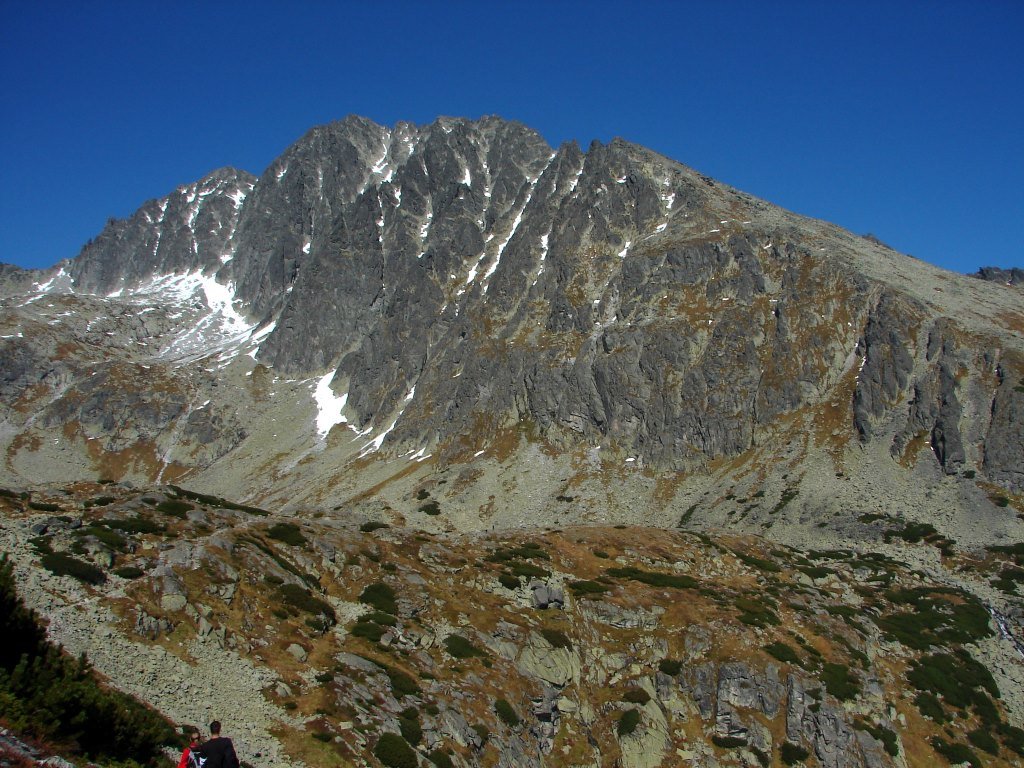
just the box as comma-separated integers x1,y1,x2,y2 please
0,483,1024,768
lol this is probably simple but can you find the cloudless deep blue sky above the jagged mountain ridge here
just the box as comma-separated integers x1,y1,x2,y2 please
0,0,1024,271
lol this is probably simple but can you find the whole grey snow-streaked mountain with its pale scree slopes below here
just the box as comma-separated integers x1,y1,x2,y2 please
0,118,1024,552
